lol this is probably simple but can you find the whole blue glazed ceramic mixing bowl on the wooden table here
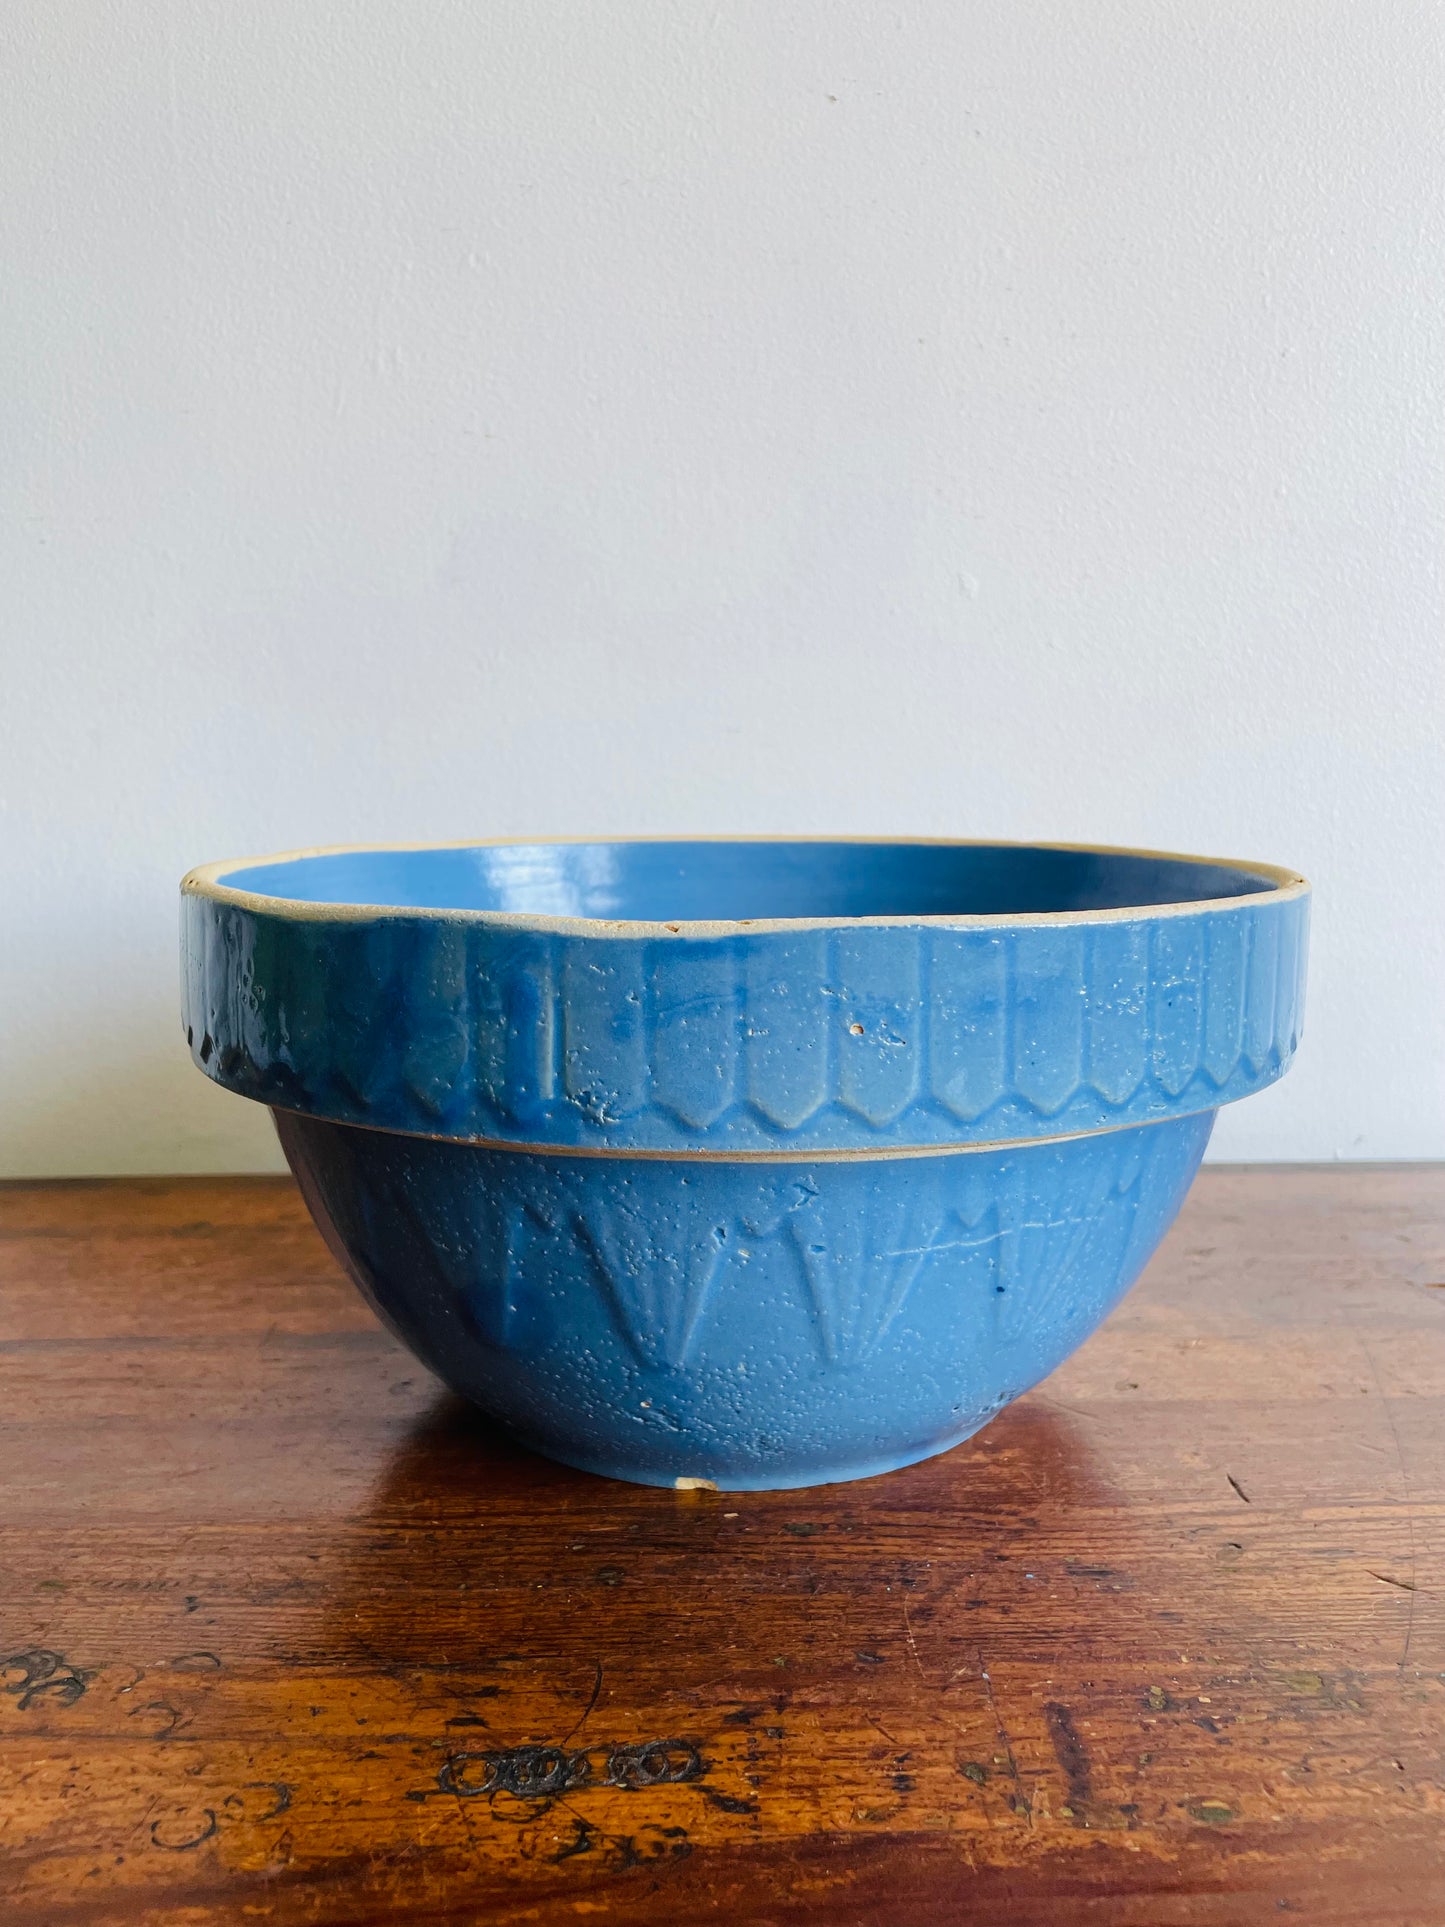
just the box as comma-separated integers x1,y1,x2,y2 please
181,840,1308,1490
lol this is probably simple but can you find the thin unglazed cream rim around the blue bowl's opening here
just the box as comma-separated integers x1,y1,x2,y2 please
181,832,1310,940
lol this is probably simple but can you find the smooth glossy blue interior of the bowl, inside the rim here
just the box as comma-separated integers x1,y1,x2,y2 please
220,840,1277,923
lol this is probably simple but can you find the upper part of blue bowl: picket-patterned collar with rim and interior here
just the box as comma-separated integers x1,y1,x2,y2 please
183,842,1308,1154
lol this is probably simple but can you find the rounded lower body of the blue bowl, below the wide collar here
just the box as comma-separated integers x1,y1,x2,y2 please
277,1112,1214,1490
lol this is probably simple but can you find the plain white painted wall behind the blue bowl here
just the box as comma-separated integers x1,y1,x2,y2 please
0,0,1445,1174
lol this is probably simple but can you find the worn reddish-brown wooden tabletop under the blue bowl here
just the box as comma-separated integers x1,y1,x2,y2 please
0,1168,1445,1927
